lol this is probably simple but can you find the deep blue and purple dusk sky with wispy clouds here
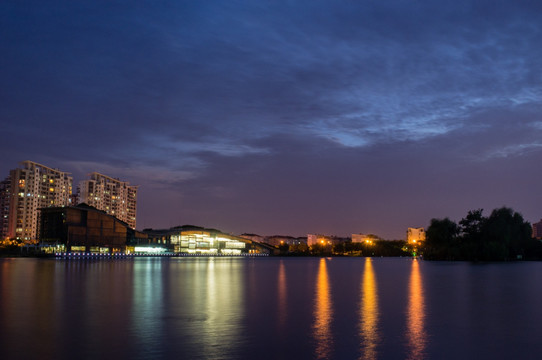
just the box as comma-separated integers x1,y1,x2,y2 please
0,0,542,239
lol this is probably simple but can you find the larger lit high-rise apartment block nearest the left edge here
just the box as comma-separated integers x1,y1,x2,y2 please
6,161,73,240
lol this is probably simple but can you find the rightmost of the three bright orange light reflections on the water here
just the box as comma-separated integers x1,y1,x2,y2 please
406,260,427,359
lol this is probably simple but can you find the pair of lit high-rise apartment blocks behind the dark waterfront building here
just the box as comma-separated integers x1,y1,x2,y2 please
0,161,137,243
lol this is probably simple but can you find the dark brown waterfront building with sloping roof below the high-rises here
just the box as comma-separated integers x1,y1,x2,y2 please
39,204,147,253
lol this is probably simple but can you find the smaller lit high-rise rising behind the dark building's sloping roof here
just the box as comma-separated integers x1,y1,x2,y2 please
79,172,137,229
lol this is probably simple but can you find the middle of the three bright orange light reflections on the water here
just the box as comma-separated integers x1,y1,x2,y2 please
359,258,379,359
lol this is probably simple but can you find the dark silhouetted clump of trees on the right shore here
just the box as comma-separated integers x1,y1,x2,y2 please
423,207,542,261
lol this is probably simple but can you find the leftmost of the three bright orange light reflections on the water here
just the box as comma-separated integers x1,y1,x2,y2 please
313,258,333,359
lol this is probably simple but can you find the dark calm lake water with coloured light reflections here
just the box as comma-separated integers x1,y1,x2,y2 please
0,258,542,359
